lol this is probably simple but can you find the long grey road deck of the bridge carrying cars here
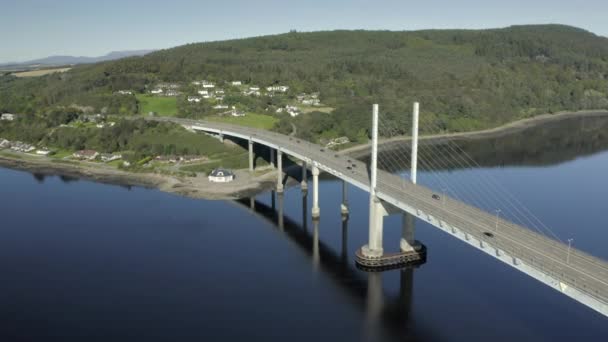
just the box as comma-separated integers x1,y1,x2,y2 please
155,118,608,315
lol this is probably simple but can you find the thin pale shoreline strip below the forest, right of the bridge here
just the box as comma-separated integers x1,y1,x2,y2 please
337,110,608,158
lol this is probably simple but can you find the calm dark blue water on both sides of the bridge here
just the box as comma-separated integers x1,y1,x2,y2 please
0,119,608,341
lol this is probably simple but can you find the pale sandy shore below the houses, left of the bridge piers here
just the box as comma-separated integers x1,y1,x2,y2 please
0,154,276,200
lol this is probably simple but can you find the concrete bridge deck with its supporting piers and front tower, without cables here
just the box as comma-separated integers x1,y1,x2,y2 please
152,107,608,316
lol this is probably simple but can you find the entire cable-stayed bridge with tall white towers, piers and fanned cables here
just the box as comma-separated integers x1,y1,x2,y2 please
150,104,608,316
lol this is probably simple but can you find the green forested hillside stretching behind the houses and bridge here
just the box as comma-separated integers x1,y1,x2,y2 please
0,25,608,140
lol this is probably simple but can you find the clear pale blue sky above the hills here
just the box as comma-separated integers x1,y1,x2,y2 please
0,0,608,63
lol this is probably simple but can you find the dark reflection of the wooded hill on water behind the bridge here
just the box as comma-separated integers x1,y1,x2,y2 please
361,116,608,172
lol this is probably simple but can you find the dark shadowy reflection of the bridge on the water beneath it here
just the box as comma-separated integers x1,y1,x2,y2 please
235,192,435,341
